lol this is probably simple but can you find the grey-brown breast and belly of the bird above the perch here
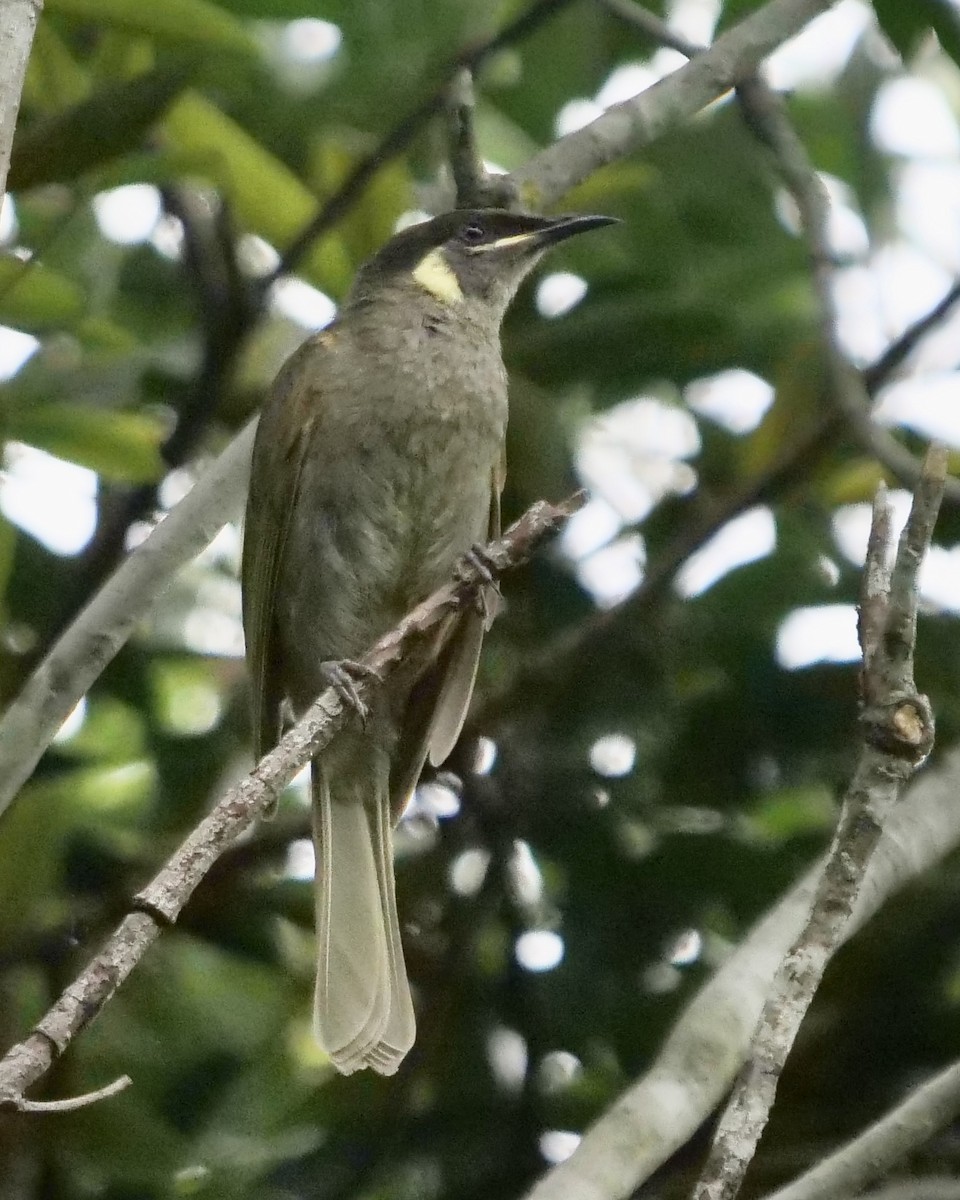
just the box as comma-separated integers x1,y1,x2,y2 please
277,316,506,676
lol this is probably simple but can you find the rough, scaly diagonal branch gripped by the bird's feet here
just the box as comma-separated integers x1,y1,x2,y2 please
0,493,583,1108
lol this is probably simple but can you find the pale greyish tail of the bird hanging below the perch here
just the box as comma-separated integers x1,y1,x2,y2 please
312,751,415,1075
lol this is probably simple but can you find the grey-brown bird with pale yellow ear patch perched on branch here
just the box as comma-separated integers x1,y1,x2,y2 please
241,209,613,1075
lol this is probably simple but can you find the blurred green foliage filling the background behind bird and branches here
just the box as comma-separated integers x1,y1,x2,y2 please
0,0,960,1200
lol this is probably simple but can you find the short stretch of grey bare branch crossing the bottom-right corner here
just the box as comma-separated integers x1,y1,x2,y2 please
767,1062,960,1200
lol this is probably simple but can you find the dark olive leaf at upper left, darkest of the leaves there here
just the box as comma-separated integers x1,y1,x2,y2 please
7,67,187,191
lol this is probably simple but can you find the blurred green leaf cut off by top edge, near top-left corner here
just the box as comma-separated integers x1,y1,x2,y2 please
47,0,256,54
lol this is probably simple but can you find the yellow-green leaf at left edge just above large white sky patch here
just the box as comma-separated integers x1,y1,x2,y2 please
7,404,163,484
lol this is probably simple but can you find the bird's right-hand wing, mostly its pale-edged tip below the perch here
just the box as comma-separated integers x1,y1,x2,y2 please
390,456,505,821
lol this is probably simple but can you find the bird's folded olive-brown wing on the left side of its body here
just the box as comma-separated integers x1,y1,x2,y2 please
241,328,336,761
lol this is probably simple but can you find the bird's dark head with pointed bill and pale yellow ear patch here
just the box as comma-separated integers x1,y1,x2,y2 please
353,209,616,322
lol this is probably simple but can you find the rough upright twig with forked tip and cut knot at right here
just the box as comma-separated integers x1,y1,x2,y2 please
694,446,947,1200
